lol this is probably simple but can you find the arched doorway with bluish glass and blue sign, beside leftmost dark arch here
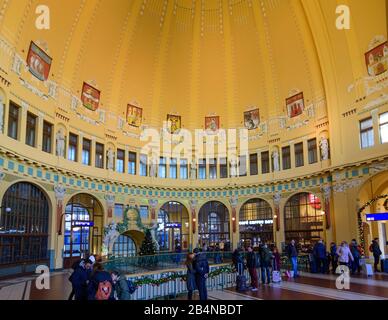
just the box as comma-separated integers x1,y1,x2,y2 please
63,193,104,268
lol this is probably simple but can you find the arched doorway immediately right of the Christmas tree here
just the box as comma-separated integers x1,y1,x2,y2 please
156,201,189,251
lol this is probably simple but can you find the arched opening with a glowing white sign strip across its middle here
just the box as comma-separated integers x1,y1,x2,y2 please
239,199,274,246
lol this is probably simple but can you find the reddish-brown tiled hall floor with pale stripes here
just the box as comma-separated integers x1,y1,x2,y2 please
0,271,388,300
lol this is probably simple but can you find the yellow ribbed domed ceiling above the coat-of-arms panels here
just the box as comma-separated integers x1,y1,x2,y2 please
0,0,324,128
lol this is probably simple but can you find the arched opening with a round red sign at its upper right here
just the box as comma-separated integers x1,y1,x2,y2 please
284,192,324,247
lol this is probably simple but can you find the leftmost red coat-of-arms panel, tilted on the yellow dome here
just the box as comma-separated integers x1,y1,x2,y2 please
27,41,52,81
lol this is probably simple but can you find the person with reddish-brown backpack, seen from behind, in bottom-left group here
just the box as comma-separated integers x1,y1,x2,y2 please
88,263,115,300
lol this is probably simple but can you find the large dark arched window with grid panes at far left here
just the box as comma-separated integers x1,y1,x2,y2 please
0,182,49,266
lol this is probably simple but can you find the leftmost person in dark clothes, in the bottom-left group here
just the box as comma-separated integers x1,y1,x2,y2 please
69,259,93,300
